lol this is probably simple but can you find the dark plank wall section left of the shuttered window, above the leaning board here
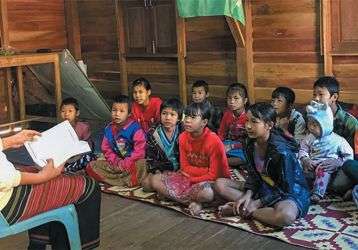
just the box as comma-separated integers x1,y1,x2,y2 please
77,0,120,101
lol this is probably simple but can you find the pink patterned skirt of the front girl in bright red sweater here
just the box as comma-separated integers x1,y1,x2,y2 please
162,171,210,204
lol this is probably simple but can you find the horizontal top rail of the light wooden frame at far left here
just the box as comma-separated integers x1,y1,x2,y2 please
0,53,58,68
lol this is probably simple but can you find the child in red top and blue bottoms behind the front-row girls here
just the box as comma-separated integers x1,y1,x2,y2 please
218,83,248,166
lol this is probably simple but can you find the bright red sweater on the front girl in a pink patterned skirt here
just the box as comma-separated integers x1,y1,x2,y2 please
179,128,230,183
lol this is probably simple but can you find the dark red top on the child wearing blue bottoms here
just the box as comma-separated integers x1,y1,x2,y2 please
218,109,247,141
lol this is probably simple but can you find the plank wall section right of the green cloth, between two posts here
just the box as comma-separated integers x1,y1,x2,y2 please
251,0,323,102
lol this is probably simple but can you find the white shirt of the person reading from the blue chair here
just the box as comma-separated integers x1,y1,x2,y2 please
0,139,21,211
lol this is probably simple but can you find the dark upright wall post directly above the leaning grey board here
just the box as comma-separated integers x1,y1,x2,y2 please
64,0,82,60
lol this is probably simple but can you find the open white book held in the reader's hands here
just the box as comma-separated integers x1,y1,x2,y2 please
25,121,91,167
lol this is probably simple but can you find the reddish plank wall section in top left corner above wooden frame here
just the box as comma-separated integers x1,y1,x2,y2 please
7,0,67,52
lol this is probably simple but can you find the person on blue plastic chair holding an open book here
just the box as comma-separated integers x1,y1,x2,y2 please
0,130,101,250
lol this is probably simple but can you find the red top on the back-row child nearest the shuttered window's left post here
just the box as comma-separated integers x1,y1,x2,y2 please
132,97,162,133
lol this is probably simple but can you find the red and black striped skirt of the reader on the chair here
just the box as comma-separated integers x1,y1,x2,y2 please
1,175,101,249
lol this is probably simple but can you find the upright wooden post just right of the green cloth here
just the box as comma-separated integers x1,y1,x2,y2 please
245,0,255,103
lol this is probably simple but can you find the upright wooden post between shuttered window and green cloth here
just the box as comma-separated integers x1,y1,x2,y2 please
176,10,188,105
